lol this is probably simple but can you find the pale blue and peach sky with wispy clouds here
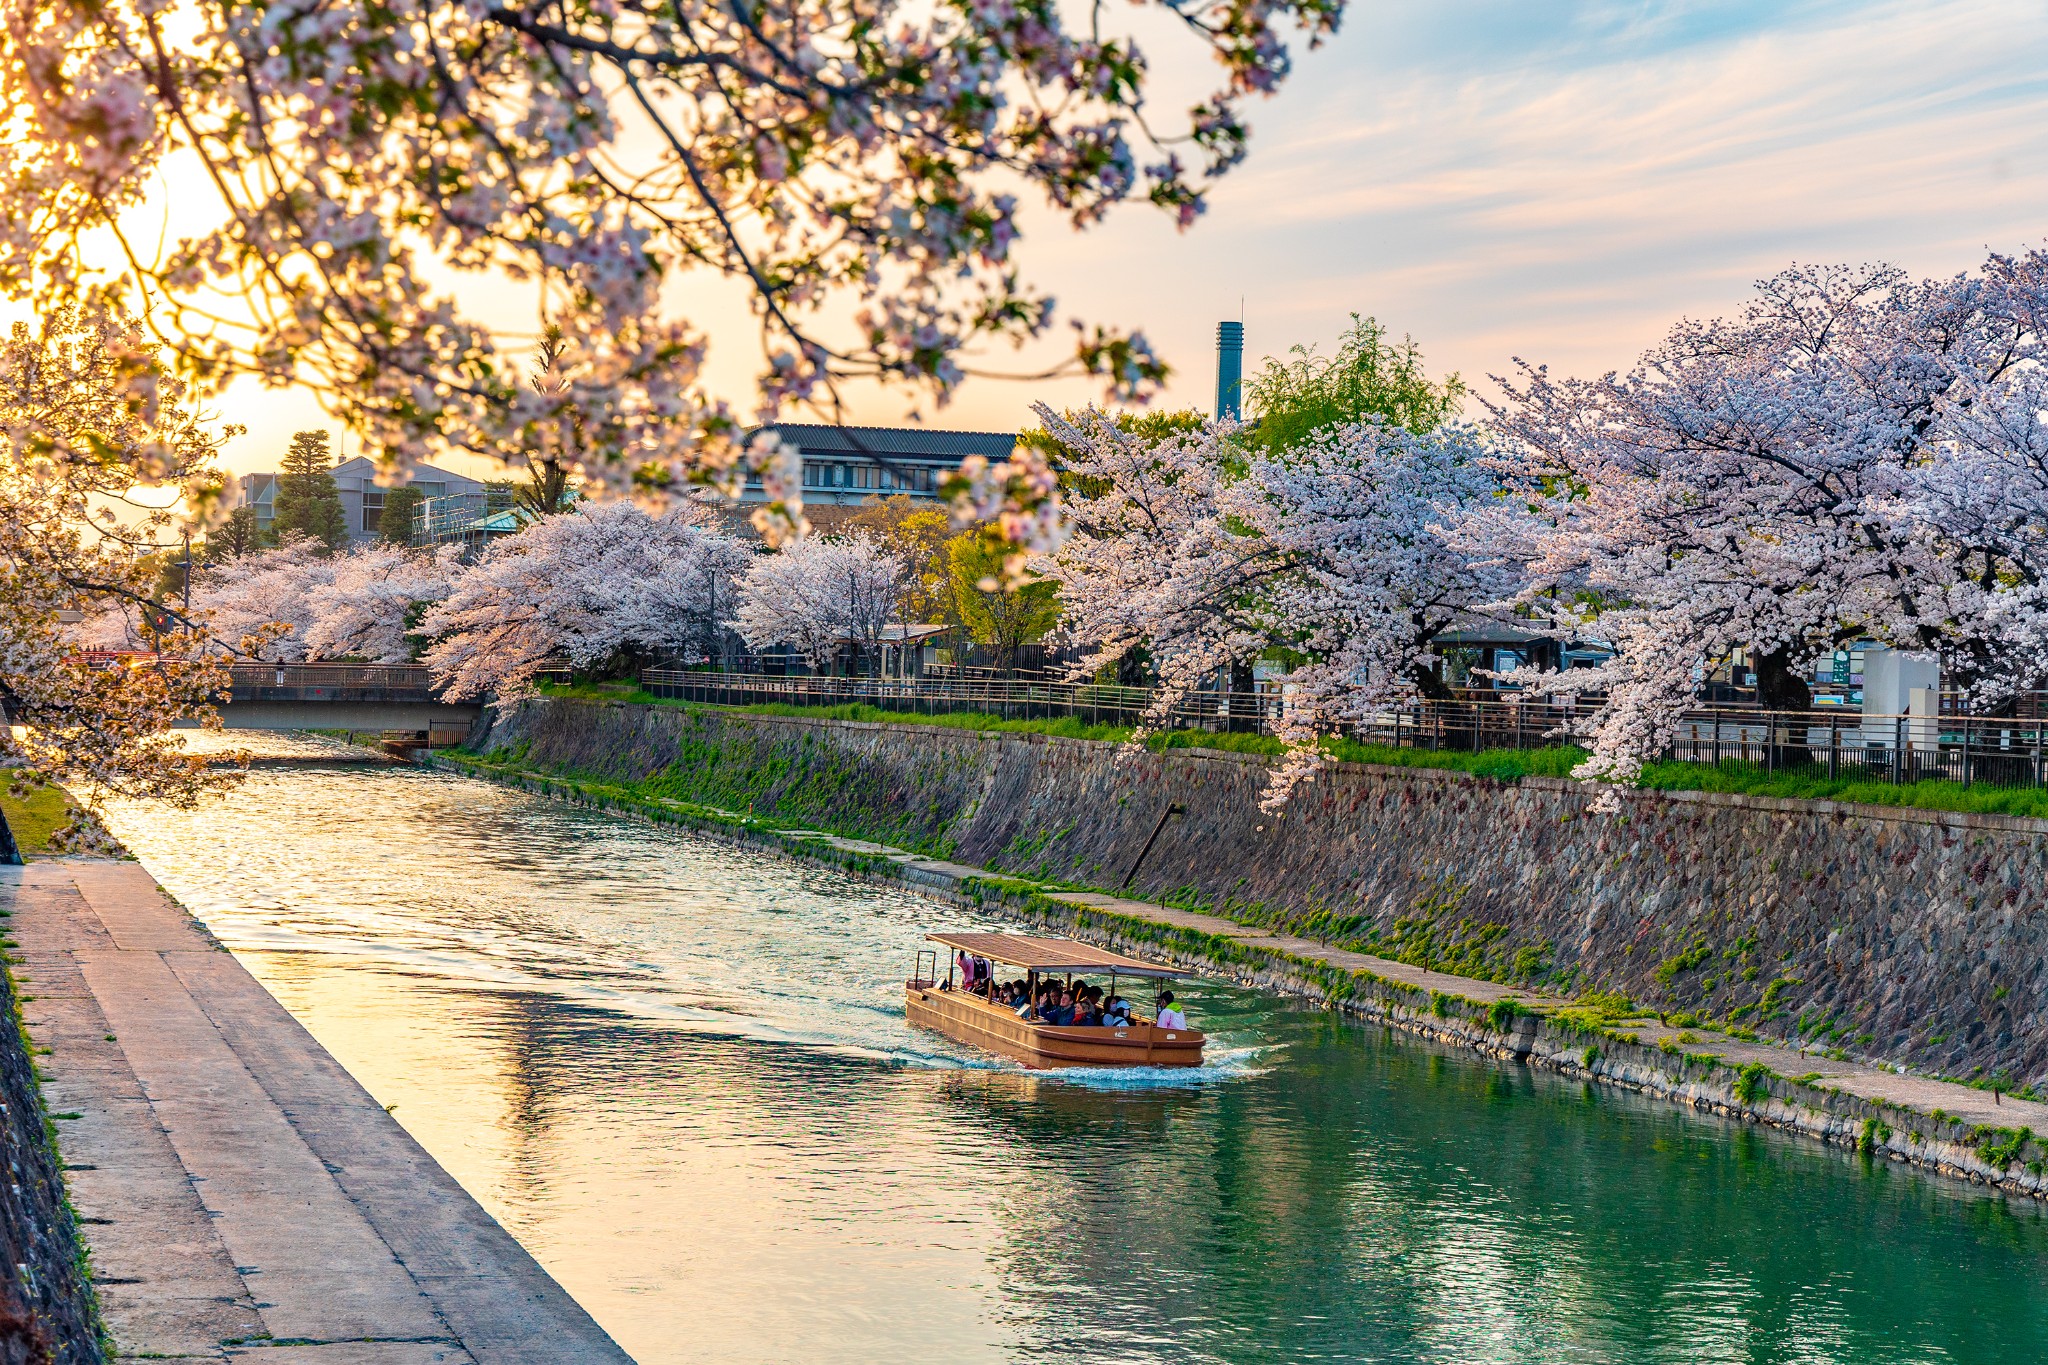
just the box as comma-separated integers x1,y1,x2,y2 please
151,0,2048,473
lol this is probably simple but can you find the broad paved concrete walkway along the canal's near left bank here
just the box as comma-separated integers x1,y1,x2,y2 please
0,860,629,1365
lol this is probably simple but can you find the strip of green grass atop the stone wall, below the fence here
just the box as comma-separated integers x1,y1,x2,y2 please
539,684,2048,819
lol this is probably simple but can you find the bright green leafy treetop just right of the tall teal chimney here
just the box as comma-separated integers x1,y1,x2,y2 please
1245,313,1464,454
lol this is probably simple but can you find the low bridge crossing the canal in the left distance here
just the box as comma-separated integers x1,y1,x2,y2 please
188,663,483,741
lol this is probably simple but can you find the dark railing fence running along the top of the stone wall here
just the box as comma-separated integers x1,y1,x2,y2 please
641,669,2048,788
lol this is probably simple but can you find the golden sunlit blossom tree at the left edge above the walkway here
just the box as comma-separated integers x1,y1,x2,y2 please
0,307,233,845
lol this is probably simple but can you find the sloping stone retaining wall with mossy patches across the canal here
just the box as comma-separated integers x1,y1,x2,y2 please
477,700,2048,1089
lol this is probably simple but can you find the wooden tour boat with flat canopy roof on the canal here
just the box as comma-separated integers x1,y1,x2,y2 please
903,933,1204,1066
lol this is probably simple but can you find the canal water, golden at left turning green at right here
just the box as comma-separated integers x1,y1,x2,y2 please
99,737,2048,1365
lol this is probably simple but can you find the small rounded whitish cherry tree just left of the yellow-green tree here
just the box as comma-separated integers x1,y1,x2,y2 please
733,532,905,667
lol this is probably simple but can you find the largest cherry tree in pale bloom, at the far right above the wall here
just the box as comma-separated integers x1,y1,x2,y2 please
1493,252,2048,782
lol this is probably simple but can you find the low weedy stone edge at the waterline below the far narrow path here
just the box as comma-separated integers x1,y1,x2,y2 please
420,753,2048,1197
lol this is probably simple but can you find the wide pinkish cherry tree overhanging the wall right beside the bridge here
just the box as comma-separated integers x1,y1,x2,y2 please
418,503,753,700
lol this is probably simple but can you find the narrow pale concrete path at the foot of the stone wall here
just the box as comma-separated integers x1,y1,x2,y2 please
776,829,2048,1134
